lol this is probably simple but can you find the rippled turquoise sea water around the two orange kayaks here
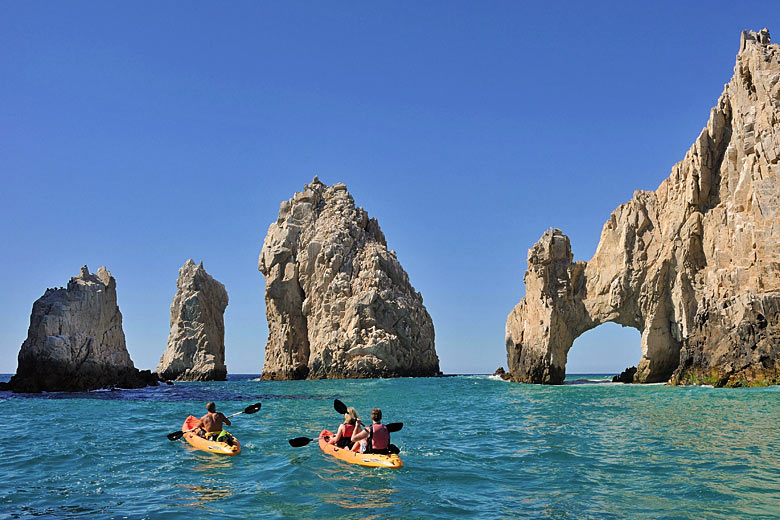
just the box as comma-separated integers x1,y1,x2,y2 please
0,376,780,519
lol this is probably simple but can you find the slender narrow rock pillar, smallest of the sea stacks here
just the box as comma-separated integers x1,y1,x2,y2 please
156,259,228,381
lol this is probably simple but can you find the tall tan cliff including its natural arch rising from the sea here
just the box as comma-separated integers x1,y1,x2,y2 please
506,29,780,386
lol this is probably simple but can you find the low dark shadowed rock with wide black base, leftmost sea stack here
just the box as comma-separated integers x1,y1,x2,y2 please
1,266,157,392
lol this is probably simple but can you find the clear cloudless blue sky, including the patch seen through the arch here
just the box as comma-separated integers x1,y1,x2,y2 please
0,0,780,373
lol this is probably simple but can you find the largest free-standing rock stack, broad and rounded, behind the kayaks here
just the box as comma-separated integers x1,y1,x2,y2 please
258,177,439,379
